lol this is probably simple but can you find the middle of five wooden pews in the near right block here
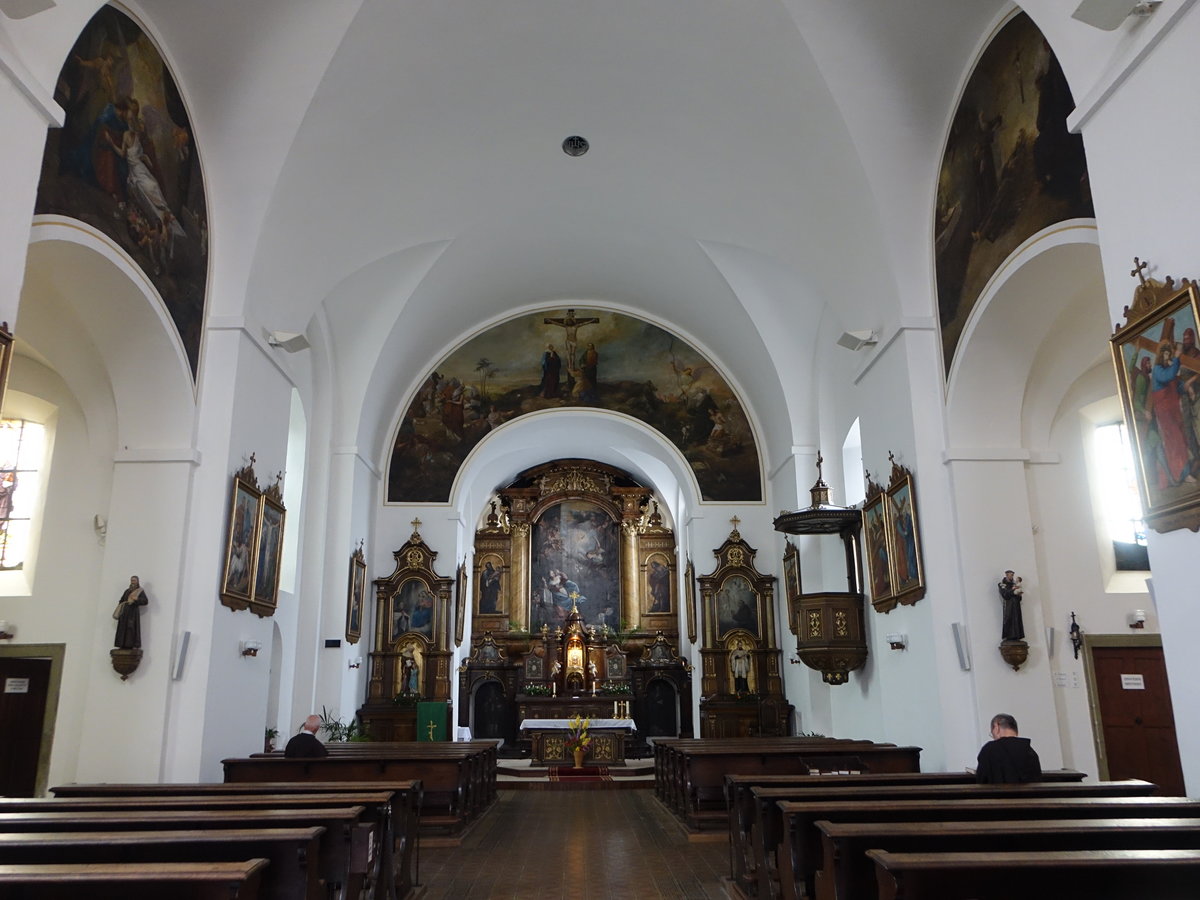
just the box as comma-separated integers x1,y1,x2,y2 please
760,785,1200,899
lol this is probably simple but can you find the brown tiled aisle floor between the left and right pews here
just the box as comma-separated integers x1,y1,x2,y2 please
420,791,730,900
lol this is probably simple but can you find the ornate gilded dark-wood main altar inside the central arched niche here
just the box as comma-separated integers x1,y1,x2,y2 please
457,460,692,763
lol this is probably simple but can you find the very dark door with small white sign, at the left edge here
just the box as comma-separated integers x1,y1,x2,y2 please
0,656,50,797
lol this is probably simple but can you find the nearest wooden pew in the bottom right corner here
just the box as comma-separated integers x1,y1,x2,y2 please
868,850,1200,900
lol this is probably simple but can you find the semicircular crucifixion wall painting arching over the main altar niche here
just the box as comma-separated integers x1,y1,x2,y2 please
388,308,762,503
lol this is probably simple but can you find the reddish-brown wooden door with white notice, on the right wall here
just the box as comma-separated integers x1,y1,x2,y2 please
1092,647,1184,797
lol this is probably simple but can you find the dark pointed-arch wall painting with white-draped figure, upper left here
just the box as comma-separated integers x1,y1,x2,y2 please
35,6,209,378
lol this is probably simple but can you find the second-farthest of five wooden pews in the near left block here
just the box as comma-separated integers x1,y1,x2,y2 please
0,784,410,900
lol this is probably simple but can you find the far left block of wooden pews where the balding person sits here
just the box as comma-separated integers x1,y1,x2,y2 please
221,740,497,835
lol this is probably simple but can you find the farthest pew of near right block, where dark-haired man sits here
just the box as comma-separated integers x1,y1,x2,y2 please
725,769,1085,895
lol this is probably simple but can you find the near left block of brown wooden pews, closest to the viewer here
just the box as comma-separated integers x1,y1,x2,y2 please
0,781,421,900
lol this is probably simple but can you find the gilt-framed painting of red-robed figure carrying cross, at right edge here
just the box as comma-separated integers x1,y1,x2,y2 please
1111,278,1200,533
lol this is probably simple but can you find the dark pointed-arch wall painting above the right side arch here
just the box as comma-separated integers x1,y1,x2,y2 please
934,13,1094,373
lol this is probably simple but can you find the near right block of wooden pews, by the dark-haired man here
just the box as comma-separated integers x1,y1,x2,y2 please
727,772,1200,900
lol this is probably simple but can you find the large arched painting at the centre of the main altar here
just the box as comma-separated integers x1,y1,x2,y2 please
529,500,620,631
